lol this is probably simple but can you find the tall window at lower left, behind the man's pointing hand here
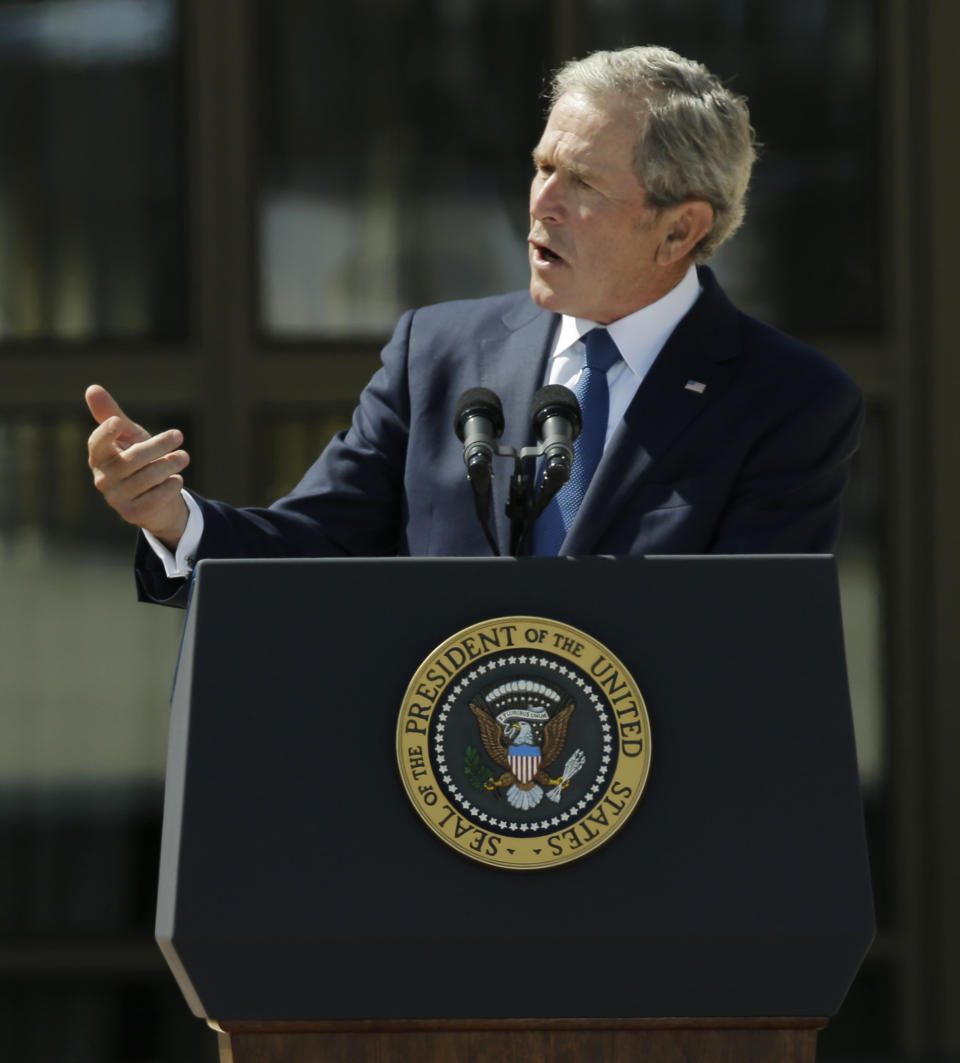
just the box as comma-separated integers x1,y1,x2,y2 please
0,414,185,918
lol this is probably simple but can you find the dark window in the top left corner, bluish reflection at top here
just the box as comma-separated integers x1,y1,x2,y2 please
0,0,186,340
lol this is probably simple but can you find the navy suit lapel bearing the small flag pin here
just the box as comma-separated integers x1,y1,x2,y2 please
560,268,740,555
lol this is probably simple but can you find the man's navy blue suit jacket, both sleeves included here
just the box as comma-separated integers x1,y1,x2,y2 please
137,268,862,604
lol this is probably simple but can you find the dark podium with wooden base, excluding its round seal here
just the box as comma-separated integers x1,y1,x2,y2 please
156,556,874,1063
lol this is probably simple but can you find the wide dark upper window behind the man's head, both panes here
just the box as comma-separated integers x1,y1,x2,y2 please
258,0,885,339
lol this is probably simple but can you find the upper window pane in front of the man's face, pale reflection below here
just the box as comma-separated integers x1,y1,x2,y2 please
257,0,550,339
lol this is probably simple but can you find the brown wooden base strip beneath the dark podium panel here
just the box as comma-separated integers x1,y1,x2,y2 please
210,1018,827,1063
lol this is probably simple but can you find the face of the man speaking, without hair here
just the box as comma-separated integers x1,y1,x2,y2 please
528,92,681,324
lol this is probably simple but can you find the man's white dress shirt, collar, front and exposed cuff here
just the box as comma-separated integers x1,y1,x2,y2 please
144,266,701,579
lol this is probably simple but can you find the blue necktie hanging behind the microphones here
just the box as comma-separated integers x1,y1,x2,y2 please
533,328,620,556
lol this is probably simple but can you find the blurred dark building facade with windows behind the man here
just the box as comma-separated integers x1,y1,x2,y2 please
0,0,960,1063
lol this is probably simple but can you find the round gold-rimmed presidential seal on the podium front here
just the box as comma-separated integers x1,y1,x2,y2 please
397,617,651,871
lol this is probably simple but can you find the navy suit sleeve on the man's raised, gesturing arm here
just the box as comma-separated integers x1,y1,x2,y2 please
136,313,412,606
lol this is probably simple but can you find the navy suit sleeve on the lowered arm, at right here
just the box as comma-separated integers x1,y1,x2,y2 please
710,373,863,554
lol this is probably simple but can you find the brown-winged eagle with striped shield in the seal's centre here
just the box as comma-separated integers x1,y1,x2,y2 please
470,701,583,810
